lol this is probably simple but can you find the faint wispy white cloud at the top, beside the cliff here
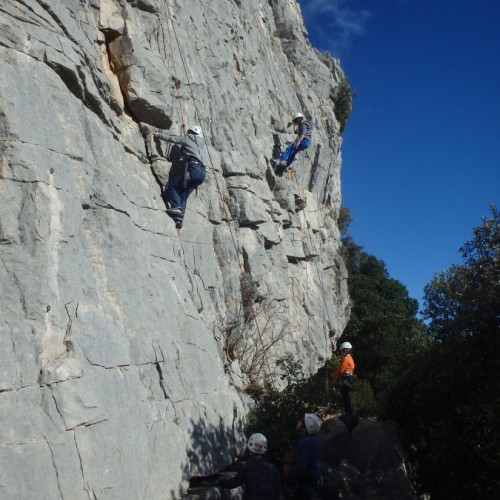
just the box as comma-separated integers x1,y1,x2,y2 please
299,0,371,57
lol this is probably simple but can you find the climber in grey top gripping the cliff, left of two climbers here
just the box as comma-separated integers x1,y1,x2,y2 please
148,125,207,229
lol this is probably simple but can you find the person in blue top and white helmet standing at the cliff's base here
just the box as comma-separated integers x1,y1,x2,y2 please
283,413,321,499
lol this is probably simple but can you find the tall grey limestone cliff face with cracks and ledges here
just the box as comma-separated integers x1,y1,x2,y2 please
0,0,349,499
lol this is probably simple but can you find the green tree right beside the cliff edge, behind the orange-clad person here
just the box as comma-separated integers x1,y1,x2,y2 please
343,237,428,402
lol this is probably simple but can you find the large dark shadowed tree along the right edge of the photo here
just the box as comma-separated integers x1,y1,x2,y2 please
390,206,500,500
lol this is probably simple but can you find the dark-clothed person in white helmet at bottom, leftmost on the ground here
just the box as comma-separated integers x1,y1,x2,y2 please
218,433,282,500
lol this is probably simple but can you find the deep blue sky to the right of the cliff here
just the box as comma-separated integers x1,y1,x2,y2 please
299,0,500,302
